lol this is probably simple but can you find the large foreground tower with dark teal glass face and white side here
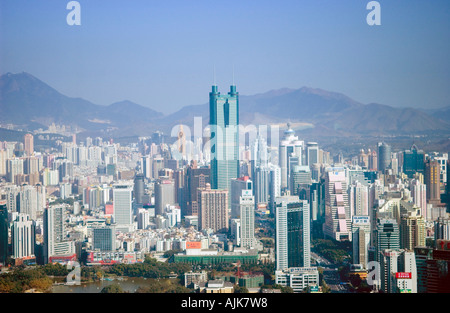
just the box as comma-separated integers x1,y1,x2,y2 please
275,196,311,270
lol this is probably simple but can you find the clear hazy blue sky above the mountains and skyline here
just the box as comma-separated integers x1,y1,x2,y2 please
0,0,450,113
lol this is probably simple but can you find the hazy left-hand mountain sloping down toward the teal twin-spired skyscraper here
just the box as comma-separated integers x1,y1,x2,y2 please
0,73,162,135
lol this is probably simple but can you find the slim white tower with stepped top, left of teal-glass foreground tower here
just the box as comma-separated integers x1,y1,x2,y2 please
239,190,256,249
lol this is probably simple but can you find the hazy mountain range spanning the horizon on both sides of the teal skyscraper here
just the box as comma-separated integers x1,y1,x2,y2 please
0,73,450,137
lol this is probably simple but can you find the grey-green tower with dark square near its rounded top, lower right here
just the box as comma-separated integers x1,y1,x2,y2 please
374,219,400,262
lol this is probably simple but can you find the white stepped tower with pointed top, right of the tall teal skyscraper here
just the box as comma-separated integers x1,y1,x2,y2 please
278,124,304,189
